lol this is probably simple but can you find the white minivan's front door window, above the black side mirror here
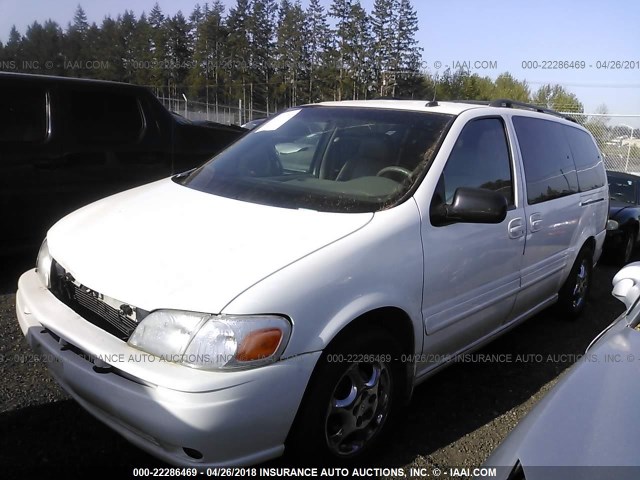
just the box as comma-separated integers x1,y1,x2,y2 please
436,118,513,205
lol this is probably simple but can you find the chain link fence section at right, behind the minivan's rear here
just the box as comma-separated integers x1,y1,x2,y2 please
564,112,640,175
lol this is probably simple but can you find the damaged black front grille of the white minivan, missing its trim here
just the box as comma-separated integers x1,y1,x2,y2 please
51,260,148,341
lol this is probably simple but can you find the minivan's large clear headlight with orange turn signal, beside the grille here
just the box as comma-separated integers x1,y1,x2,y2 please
127,310,291,370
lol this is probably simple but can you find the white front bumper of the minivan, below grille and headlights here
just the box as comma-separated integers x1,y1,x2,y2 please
16,270,320,467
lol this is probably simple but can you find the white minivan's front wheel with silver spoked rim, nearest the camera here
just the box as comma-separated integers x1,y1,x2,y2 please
287,331,403,464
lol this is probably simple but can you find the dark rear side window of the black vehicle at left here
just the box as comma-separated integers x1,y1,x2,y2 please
69,91,144,144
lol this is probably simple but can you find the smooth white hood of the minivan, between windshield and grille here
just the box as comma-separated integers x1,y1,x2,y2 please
47,179,373,313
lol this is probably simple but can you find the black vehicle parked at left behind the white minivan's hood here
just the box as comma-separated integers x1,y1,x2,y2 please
0,73,245,255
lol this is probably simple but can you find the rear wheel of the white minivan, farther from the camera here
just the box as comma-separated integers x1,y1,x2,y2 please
558,247,593,319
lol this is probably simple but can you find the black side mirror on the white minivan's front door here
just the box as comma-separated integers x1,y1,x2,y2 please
431,187,508,226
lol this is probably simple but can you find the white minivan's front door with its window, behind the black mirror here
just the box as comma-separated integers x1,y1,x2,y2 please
422,117,526,359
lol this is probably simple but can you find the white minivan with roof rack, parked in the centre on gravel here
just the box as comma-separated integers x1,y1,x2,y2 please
16,100,609,467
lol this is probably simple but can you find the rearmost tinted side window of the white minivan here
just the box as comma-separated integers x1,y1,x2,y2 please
563,125,607,192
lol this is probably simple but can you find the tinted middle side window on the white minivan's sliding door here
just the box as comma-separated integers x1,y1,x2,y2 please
513,116,578,205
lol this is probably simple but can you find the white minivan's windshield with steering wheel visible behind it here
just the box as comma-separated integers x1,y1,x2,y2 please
179,107,454,212
